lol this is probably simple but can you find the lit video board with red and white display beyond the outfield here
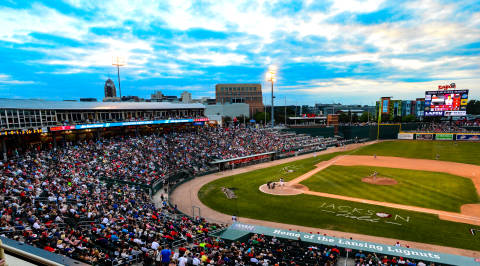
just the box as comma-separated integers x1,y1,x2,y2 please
425,90,468,116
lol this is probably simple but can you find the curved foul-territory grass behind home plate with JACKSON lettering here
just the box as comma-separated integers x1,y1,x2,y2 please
199,154,480,250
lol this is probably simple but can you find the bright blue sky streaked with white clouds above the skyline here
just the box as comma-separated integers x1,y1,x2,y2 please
0,0,480,104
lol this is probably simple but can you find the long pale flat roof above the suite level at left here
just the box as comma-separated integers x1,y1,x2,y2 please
0,98,205,110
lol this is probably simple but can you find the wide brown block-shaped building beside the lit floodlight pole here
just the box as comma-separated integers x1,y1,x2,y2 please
215,83,264,115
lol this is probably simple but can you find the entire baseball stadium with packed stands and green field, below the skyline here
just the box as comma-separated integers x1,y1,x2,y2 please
0,90,480,265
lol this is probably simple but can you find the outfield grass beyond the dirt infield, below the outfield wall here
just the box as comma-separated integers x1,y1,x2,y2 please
352,140,480,165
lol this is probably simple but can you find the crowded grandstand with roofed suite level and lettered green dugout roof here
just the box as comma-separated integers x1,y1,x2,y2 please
0,100,475,265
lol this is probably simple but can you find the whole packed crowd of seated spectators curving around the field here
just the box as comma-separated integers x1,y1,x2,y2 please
0,125,436,265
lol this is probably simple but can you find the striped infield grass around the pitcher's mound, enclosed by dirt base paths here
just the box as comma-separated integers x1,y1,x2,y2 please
301,165,479,212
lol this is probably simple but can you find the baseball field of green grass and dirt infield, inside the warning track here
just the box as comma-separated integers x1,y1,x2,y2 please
198,141,480,251
